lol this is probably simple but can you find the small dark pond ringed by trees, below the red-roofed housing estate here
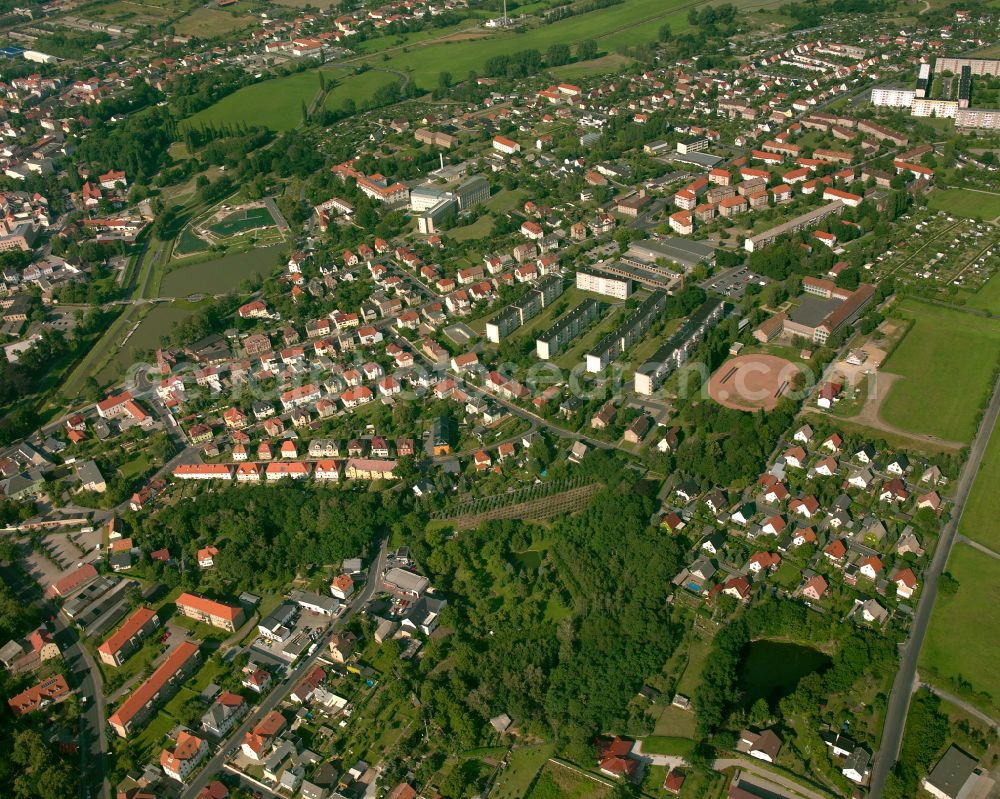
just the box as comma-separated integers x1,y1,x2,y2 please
739,639,831,707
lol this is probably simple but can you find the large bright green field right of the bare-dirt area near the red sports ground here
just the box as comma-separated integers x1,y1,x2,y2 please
880,300,1000,442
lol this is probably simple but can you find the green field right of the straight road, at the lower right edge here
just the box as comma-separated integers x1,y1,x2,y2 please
920,544,1000,718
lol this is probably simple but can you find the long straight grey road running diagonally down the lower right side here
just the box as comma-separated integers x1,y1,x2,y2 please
869,372,1000,799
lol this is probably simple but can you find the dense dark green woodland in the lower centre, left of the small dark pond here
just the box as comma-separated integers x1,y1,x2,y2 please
413,453,682,762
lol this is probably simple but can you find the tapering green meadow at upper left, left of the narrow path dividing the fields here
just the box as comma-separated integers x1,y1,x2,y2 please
184,71,336,131
